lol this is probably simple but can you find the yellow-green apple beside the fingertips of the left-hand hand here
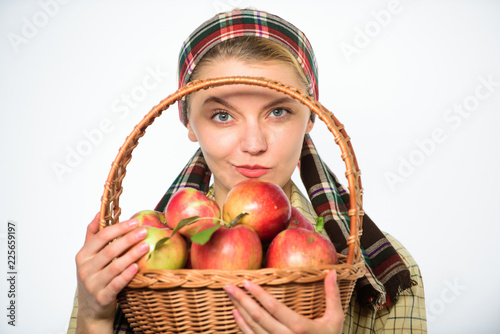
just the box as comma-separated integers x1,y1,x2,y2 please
137,227,188,270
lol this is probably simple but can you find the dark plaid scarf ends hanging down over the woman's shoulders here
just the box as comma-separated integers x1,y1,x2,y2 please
155,135,416,308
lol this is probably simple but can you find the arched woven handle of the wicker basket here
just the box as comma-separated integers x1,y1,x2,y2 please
99,76,363,264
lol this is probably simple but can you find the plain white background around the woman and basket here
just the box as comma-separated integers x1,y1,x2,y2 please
0,0,500,333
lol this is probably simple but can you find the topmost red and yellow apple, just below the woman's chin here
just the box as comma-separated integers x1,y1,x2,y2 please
222,179,292,241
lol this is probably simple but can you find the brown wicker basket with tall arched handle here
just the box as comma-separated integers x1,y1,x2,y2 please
99,77,365,333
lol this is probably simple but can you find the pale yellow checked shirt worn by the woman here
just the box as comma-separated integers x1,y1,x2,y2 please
68,185,427,334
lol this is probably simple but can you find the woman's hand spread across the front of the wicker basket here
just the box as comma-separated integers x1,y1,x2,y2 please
224,270,344,334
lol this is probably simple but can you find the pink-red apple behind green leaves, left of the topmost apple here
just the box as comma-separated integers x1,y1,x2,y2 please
165,188,220,237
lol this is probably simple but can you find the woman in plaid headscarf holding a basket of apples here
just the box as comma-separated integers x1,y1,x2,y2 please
72,9,426,333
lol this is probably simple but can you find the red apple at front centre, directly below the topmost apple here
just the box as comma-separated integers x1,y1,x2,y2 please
191,224,262,270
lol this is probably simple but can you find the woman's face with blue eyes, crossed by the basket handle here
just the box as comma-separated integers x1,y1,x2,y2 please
187,59,313,206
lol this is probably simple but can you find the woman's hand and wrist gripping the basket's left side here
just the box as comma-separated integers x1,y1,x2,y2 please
75,214,149,333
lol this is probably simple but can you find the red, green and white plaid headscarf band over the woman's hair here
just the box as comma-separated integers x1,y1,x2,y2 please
178,9,318,125
